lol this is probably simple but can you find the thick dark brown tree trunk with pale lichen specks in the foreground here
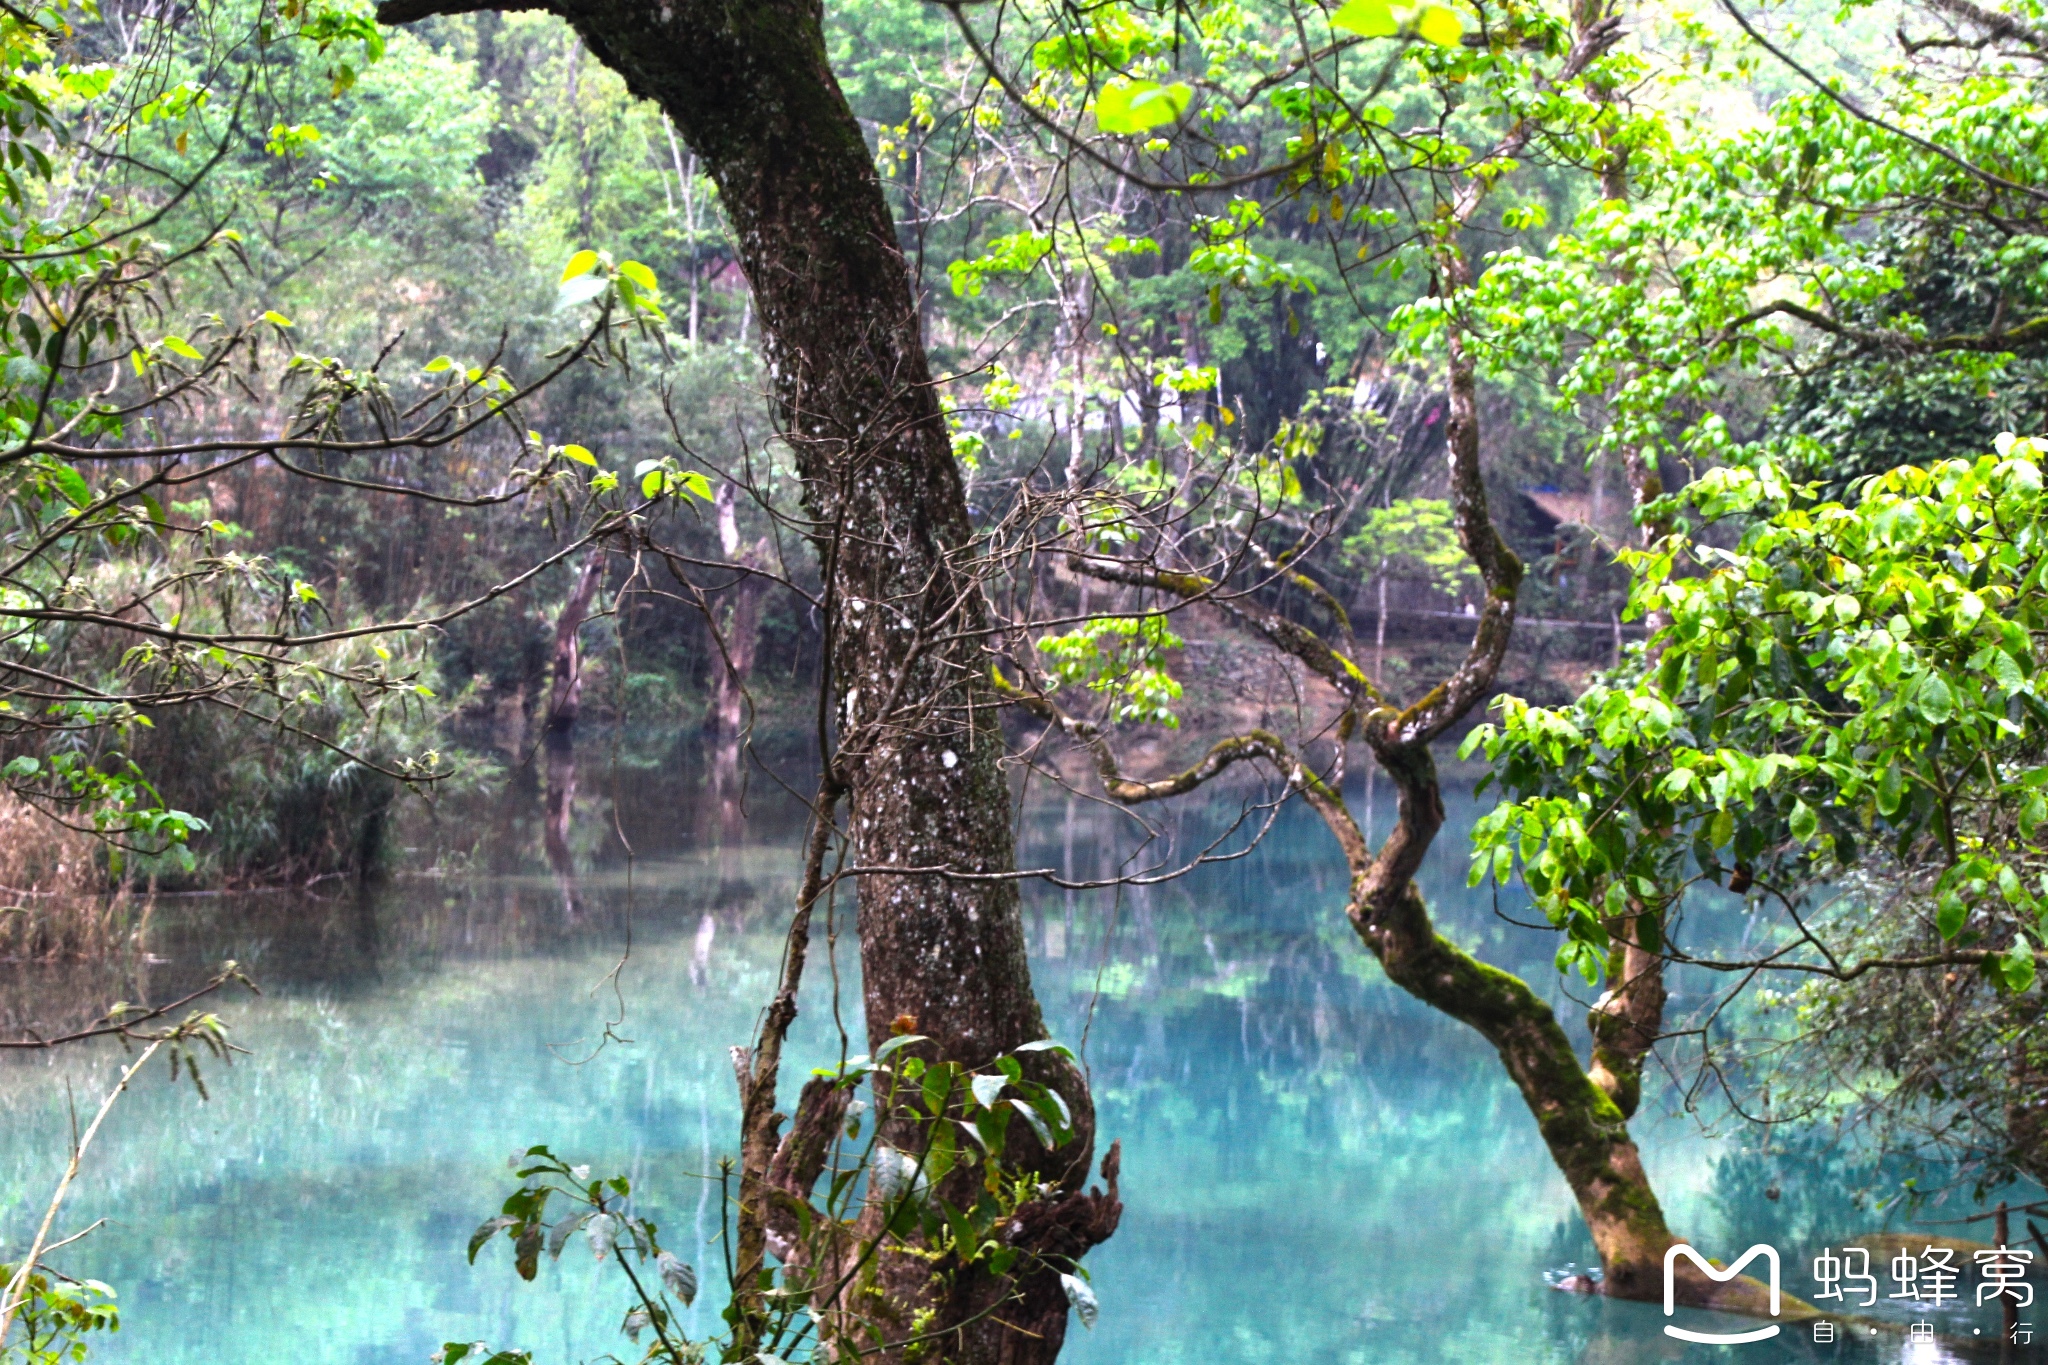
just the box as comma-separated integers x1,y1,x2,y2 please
379,0,1114,1365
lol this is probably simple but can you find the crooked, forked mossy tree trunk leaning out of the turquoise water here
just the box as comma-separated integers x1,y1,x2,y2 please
1012,4,1812,1318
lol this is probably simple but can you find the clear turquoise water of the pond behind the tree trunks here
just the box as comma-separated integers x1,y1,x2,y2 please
0,769,2048,1365
